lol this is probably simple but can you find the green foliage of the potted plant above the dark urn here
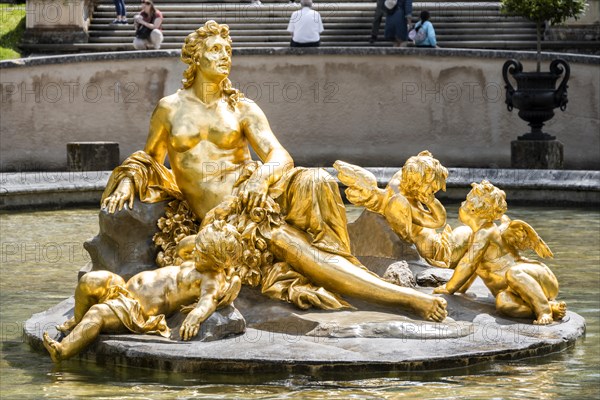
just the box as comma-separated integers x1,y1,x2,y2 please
501,0,587,25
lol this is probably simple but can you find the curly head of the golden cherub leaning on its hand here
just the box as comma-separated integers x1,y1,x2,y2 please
400,150,448,203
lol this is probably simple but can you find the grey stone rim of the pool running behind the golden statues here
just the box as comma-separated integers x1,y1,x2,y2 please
0,167,600,210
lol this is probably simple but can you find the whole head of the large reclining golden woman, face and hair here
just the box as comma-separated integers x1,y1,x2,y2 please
181,20,243,108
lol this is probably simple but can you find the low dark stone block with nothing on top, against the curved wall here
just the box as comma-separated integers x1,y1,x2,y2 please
67,142,119,171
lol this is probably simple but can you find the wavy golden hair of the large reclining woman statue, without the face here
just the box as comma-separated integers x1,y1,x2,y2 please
181,20,244,109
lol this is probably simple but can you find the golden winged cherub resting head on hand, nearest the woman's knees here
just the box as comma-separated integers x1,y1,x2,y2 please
333,150,452,268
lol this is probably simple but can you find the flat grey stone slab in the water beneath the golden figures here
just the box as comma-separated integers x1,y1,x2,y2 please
24,266,585,377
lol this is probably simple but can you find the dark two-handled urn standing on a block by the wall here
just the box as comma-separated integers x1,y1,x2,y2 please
502,59,571,140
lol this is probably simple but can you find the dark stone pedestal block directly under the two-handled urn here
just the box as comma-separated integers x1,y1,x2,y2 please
510,140,563,169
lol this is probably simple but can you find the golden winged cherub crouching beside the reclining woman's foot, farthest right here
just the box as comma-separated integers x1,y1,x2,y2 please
434,180,567,325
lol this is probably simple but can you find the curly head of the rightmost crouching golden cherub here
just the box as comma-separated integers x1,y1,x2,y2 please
459,180,507,221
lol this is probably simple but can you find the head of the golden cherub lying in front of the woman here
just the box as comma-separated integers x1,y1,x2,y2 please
195,221,242,271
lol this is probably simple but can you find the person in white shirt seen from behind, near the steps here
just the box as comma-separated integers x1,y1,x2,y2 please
287,0,325,47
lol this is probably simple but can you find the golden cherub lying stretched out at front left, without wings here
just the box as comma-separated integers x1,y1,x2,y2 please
43,221,242,362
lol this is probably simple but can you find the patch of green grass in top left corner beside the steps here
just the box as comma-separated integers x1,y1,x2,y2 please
0,4,25,60
